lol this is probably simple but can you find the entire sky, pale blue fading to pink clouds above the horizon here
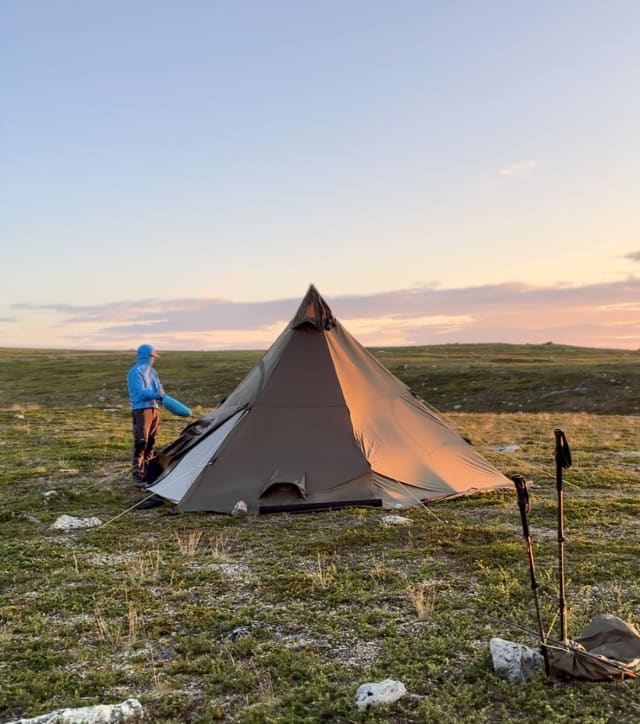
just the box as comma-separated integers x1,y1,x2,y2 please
0,0,640,350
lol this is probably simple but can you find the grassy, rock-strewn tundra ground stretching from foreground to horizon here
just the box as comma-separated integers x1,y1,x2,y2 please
0,345,640,724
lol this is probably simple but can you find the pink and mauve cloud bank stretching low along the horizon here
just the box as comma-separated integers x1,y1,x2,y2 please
0,279,640,349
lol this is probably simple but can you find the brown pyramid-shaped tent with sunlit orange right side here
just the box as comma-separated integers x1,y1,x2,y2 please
150,286,511,513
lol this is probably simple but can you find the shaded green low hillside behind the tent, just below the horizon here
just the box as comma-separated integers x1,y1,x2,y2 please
0,344,640,415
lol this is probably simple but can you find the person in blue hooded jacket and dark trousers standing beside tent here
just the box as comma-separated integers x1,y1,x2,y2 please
127,344,164,482
